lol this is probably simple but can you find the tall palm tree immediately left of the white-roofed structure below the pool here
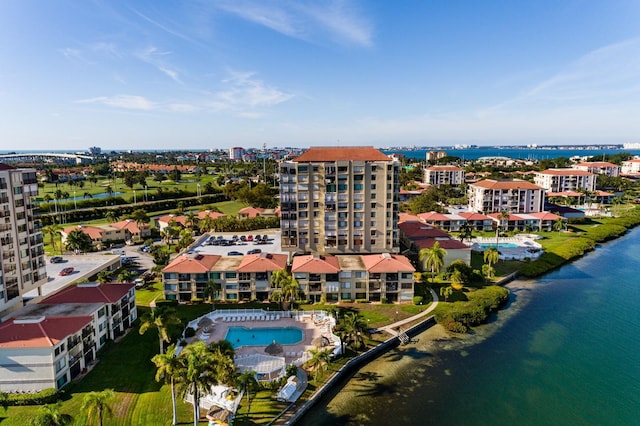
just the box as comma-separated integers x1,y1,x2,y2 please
179,341,216,426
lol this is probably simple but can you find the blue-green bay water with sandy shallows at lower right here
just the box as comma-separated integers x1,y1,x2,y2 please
301,229,640,425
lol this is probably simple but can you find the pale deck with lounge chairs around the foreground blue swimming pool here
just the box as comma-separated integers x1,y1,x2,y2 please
196,316,330,363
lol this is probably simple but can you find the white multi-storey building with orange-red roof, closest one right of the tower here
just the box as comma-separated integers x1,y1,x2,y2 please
469,179,545,214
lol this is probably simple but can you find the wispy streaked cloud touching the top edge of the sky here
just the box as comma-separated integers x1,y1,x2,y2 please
215,0,373,47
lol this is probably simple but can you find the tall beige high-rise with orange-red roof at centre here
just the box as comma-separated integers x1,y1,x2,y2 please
280,147,400,254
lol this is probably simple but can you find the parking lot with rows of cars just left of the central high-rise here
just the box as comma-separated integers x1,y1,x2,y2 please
191,229,282,256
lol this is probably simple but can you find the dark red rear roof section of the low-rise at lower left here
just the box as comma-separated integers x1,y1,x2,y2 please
40,283,134,304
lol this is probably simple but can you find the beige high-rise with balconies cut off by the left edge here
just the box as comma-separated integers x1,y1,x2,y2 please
0,164,47,316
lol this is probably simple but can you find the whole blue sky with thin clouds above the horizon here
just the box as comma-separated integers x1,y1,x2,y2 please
0,0,640,151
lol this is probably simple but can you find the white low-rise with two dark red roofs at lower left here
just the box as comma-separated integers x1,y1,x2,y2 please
0,283,137,392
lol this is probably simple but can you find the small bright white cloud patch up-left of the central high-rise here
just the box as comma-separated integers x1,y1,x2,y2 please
210,71,294,117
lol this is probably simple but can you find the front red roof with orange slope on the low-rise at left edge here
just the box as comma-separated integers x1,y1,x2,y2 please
0,316,93,348
